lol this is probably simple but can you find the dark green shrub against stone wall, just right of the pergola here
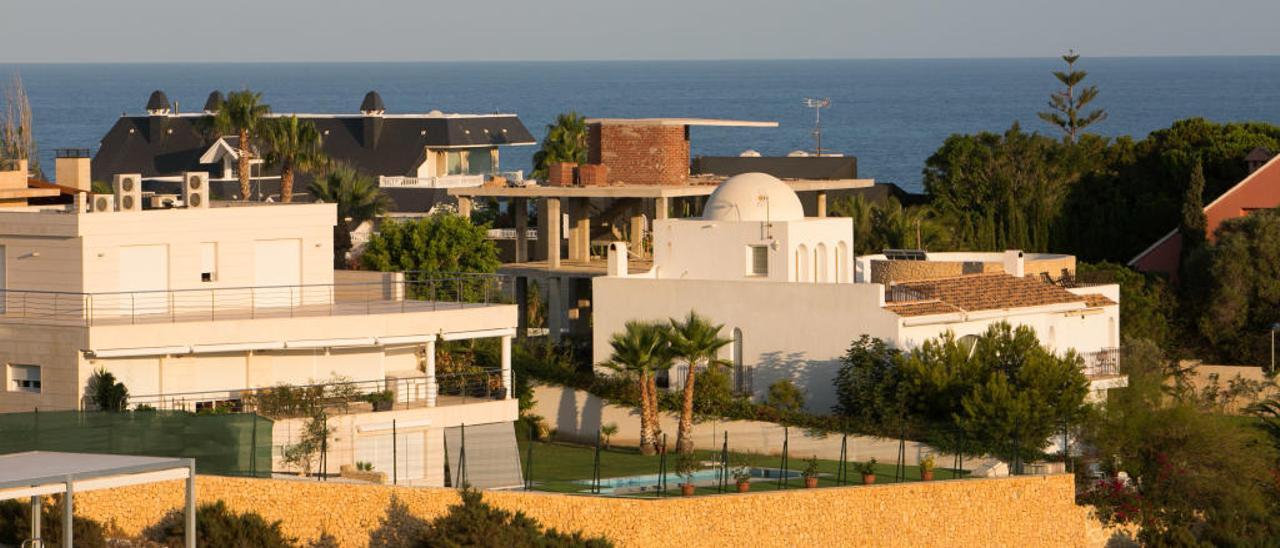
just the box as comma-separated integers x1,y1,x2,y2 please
142,501,297,548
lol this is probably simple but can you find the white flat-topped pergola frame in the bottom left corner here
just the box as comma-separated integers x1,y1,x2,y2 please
0,451,196,548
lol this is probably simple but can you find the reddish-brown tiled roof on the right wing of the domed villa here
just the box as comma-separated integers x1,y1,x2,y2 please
886,273,1088,316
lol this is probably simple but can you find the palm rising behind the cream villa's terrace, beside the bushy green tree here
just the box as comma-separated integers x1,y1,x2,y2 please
307,165,390,269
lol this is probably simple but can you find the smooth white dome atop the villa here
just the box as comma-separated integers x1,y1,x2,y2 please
703,173,804,222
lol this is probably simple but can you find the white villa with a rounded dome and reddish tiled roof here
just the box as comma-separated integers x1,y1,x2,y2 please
593,173,1126,412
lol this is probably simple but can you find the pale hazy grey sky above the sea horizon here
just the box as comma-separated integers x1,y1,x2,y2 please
0,0,1280,63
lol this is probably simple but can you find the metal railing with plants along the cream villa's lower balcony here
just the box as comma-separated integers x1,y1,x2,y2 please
126,369,508,417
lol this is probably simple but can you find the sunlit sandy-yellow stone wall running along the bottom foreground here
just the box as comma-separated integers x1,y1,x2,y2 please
76,475,1106,547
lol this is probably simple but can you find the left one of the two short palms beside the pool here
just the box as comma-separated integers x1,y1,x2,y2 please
603,321,671,455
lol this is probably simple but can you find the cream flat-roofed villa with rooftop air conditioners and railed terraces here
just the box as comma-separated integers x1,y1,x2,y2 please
0,165,520,487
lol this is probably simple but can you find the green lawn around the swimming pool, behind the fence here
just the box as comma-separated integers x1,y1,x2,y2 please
517,429,965,496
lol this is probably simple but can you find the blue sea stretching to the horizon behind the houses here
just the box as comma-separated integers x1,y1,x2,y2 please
0,56,1280,191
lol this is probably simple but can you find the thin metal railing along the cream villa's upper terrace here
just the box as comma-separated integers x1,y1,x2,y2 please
0,273,509,325
